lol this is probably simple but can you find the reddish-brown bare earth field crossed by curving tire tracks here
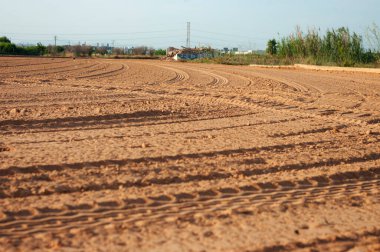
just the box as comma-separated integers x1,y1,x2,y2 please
0,57,380,251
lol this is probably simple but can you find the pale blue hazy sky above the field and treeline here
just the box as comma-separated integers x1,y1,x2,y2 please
0,0,380,50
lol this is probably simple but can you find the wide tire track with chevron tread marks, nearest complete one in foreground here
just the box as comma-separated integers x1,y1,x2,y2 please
0,168,380,238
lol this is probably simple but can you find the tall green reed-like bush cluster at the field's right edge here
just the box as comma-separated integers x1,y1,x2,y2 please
267,27,378,66
